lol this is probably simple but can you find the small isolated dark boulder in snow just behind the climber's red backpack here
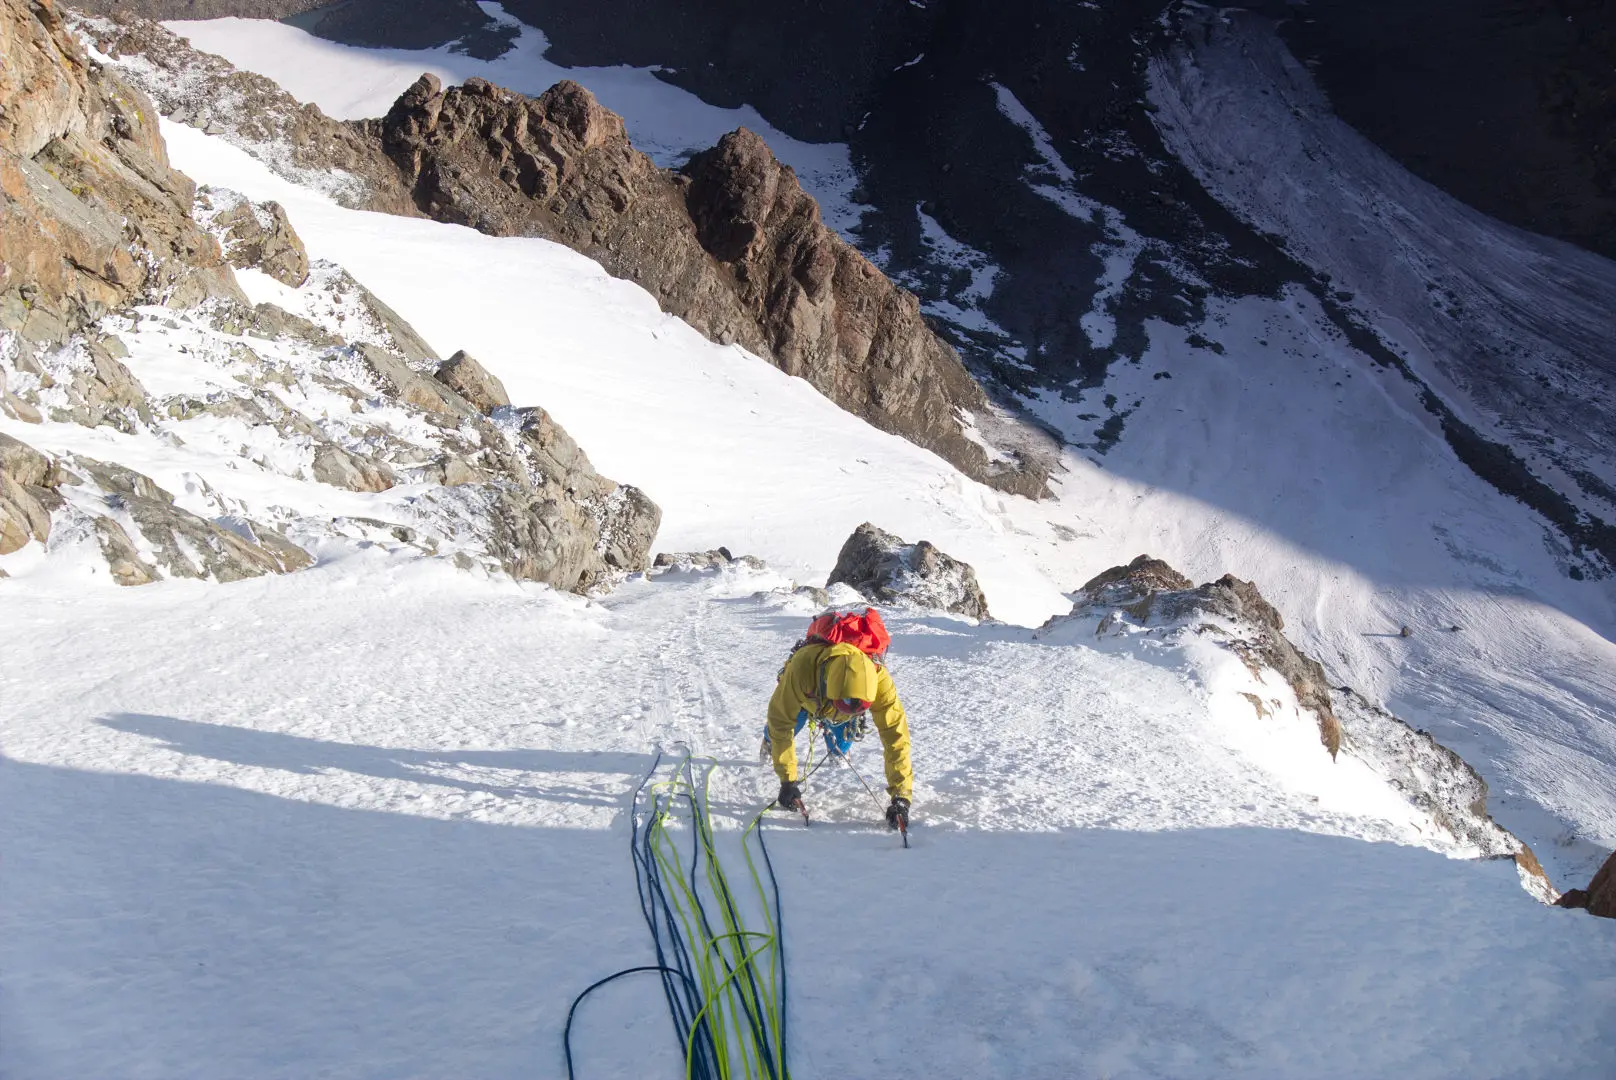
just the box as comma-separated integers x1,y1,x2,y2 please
824,521,991,619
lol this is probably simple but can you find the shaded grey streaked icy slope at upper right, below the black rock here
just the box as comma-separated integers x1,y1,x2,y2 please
1151,11,1616,552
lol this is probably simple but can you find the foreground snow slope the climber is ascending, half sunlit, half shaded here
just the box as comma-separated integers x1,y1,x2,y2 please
9,553,1616,1080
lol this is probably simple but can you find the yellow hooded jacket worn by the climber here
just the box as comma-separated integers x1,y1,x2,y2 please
769,643,915,799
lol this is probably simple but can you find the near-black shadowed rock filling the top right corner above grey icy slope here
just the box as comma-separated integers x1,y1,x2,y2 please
1259,0,1616,259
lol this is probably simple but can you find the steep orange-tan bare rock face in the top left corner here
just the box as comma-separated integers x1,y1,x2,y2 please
0,0,241,343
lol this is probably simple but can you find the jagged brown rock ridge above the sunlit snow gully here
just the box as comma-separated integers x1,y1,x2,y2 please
362,74,1047,495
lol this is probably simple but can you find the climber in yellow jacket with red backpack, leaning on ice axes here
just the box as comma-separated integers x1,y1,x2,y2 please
763,610,915,833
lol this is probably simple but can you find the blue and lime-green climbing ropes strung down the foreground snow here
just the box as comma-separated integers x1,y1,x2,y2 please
562,752,790,1080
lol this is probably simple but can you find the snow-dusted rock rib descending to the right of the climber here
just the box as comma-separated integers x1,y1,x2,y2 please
1060,555,1556,902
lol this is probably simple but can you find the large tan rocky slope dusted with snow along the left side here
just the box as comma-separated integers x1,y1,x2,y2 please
0,0,661,592
